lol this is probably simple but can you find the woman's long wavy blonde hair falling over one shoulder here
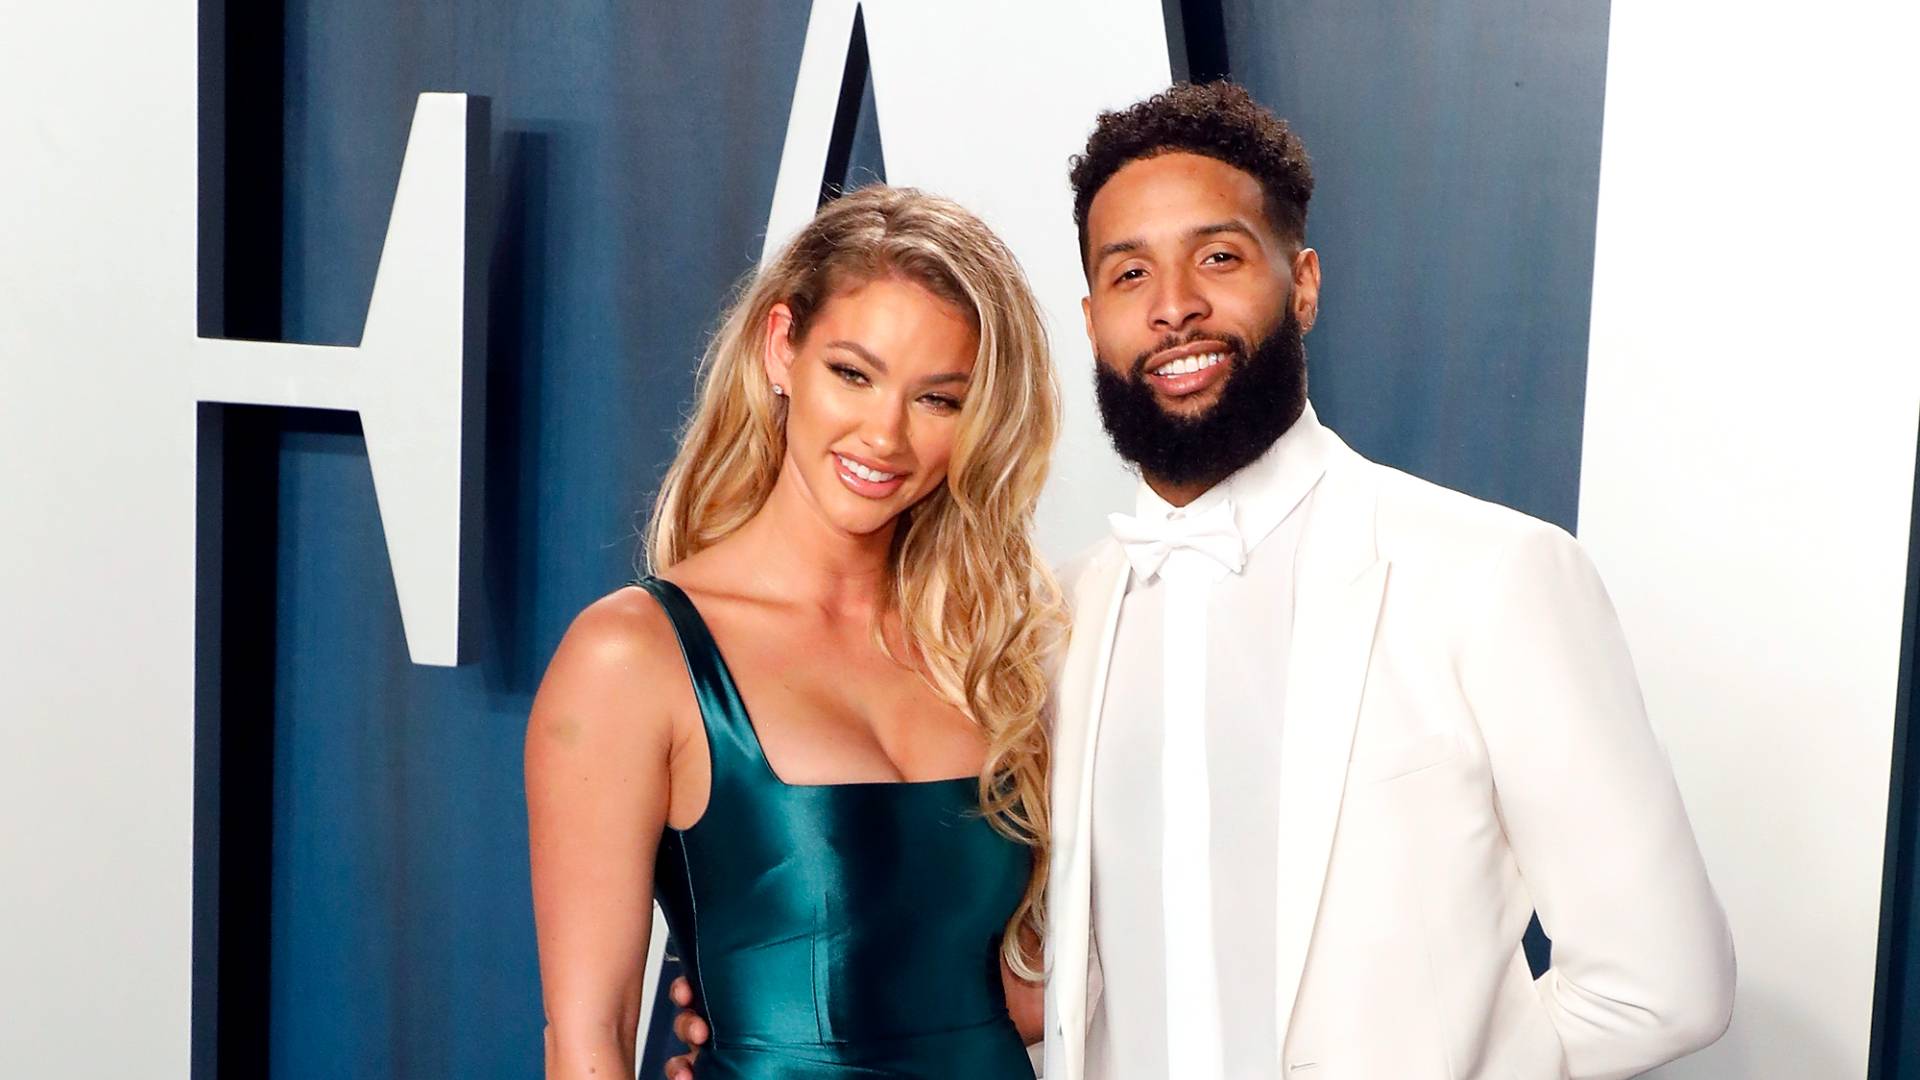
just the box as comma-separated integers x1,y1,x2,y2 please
647,184,1066,980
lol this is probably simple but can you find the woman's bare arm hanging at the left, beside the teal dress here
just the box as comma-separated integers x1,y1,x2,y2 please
526,590,684,1080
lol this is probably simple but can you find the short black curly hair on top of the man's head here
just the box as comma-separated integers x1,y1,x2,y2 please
1068,81,1313,263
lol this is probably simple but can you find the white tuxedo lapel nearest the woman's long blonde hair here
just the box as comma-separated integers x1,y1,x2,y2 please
1044,542,1129,1080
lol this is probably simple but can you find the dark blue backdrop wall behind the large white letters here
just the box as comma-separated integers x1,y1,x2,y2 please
196,0,1607,1080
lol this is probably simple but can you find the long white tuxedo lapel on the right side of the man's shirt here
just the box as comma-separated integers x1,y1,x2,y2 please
1275,440,1388,1053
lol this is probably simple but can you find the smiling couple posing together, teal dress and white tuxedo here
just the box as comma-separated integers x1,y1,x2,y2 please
526,83,1734,1080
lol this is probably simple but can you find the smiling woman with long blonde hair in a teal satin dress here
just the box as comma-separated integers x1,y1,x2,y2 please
526,186,1062,1080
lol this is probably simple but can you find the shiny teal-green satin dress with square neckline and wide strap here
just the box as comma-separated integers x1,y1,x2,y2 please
637,578,1033,1080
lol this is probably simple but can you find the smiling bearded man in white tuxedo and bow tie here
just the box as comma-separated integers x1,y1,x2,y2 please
670,83,1734,1080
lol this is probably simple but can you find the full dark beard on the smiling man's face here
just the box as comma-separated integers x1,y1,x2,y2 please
1094,311,1308,486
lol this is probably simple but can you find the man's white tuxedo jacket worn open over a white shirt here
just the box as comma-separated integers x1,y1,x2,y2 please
1044,413,1734,1080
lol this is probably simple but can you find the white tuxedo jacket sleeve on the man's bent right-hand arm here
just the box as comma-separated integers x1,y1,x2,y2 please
1459,525,1734,1080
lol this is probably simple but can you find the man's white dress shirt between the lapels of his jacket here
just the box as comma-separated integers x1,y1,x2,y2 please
1087,413,1323,1080
